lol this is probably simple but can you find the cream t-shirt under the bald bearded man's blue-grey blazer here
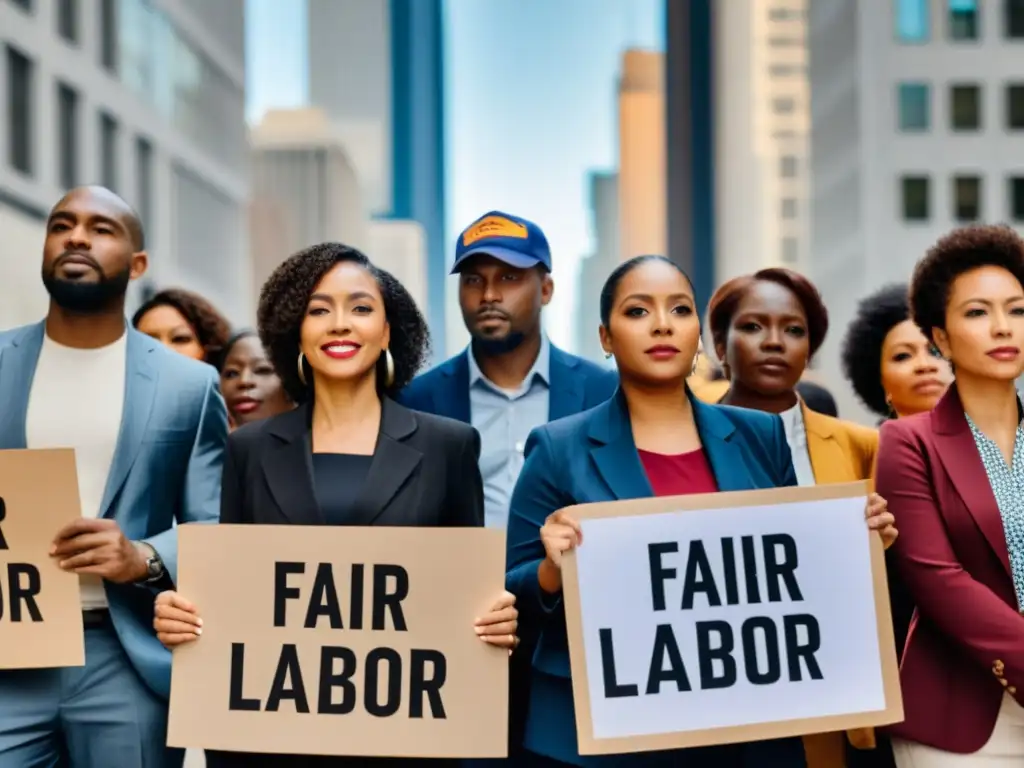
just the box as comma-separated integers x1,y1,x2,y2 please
26,334,128,610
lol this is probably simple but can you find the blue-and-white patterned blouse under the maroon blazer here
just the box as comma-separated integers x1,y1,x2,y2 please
965,414,1024,608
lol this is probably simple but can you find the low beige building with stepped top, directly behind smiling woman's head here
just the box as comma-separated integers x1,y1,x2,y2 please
250,109,369,291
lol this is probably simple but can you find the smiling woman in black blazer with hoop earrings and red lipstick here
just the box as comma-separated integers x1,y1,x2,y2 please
154,244,518,768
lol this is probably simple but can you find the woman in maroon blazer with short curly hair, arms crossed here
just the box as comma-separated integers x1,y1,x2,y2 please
877,226,1024,768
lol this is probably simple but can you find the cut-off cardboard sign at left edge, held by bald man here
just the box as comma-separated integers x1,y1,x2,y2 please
0,449,85,670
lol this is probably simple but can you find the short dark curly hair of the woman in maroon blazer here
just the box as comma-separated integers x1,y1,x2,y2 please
909,224,1024,343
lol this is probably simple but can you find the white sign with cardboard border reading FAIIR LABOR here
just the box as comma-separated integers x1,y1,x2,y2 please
562,483,903,755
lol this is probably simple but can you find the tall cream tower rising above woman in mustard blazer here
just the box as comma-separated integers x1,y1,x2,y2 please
713,0,806,283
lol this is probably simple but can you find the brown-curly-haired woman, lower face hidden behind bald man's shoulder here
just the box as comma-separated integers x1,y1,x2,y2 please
131,288,231,365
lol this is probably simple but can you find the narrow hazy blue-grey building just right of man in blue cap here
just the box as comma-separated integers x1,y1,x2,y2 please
574,172,623,362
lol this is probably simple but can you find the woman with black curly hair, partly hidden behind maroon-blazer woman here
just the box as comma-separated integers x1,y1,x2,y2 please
843,284,953,419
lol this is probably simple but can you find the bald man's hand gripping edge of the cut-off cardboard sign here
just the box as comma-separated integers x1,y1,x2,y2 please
50,517,147,584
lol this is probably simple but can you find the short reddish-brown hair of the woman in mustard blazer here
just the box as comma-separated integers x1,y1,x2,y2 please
708,267,828,357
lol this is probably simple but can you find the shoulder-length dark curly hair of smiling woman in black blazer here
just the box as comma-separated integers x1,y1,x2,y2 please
256,243,430,403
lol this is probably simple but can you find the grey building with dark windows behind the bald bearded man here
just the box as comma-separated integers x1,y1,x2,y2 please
0,0,252,327
